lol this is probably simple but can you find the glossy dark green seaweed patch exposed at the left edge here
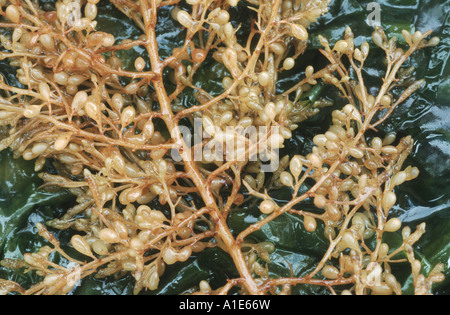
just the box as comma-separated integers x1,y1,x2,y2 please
0,151,73,283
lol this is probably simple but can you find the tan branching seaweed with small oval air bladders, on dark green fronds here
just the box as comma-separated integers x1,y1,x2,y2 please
0,0,444,295
